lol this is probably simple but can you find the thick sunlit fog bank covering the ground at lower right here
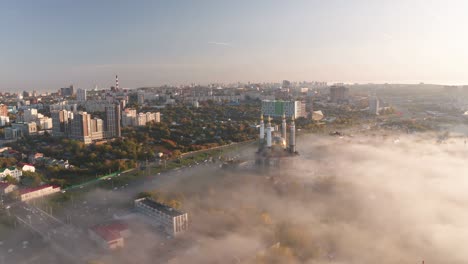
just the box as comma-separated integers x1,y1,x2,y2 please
29,134,468,264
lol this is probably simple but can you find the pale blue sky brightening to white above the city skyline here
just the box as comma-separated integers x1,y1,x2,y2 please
0,0,468,91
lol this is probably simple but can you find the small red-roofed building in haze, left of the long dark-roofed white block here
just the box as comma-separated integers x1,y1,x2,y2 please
88,222,130,250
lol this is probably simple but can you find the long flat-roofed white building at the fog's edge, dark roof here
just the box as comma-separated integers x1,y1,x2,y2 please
135,198,188,236
